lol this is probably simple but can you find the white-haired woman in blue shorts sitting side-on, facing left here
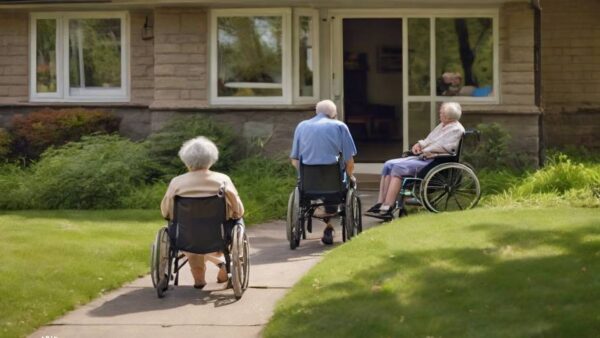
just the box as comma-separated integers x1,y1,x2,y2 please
366,102,465,219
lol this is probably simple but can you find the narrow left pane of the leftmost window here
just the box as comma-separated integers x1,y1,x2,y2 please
36,19,56,93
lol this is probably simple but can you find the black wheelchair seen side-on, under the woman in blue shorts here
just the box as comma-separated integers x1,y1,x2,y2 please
396,129,481,217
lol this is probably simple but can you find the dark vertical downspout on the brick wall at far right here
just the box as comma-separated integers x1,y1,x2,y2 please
531,0,546,167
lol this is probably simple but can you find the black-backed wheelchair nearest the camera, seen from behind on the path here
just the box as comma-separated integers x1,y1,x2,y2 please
150,189,250,299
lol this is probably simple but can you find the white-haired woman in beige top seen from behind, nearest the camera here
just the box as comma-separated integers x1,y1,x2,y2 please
160,136,244,289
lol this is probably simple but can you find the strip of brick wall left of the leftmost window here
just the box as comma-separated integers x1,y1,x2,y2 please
0,12,29,103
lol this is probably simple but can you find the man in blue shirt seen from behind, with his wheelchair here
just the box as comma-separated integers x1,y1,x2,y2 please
288,100,360,249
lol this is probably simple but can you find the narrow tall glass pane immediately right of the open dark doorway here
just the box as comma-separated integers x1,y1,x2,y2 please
408,18,431,96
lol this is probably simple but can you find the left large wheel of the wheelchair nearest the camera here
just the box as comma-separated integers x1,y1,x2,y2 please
150,227,171,298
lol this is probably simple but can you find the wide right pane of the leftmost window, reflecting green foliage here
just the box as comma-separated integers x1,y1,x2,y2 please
69,19,121,94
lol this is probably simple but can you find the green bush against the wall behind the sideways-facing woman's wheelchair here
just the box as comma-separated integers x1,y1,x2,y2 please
462,123,524,170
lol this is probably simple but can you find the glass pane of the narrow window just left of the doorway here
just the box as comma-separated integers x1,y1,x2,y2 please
298,16,313,96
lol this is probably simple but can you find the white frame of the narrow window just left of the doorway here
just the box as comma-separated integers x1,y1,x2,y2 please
293,9,321,104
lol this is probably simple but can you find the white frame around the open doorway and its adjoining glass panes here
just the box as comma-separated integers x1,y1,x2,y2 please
327,7,501,150
